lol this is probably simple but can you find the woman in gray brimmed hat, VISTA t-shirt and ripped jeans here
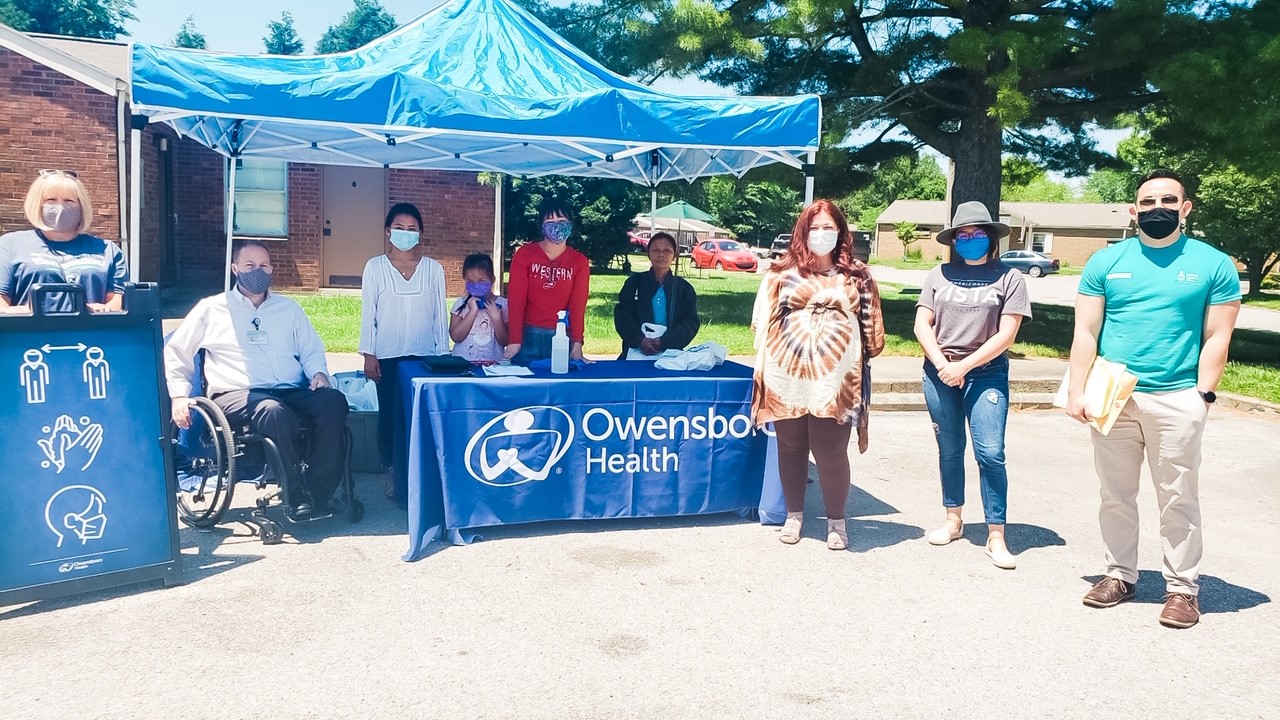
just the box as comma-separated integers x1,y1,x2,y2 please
915,202,1032,570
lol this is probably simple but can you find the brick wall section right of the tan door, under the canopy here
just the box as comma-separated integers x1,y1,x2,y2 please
387,169,497,297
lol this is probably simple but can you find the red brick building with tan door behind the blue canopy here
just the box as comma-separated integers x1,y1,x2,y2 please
0,24,495,295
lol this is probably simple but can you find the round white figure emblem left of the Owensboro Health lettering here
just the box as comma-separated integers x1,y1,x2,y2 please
466,405,573,487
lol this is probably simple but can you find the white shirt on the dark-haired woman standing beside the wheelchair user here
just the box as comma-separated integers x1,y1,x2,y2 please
360,255,449,357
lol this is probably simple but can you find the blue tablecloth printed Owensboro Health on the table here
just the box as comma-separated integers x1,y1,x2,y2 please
397,361,786,560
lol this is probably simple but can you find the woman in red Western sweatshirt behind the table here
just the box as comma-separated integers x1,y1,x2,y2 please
503,201,591,365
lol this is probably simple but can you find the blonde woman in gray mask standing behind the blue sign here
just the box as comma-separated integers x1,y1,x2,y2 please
0,170,127,313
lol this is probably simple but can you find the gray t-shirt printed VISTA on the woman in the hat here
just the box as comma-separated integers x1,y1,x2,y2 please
915,260,1032,360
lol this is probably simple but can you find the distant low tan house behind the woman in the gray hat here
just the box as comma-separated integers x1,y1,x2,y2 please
872,200,1133,266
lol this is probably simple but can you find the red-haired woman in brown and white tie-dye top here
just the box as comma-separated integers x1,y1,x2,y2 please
751,200,884,550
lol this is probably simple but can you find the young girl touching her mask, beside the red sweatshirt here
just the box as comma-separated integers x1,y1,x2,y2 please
449,252,507,363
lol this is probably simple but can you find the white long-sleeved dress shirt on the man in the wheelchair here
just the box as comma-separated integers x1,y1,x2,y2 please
164,288,329,397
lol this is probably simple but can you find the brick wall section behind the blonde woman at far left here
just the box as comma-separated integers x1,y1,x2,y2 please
0,47,120,242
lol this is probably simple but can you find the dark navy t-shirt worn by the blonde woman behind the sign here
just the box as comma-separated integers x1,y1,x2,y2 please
0,229,128,313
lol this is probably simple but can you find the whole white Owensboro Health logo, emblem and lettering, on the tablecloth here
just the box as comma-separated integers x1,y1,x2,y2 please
466,405,757,487
